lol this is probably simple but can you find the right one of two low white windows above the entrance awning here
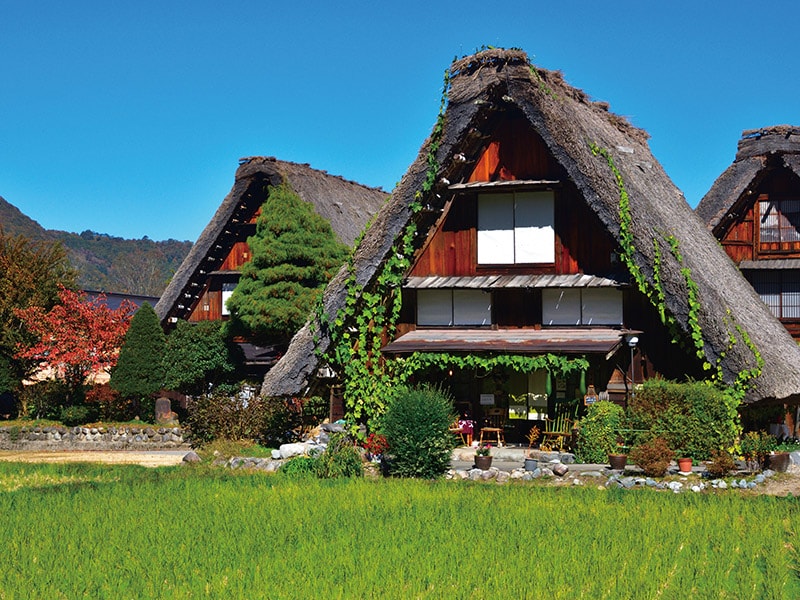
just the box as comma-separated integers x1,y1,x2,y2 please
542,288,622,325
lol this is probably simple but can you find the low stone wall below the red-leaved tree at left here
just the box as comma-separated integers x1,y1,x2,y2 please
0,426,190,450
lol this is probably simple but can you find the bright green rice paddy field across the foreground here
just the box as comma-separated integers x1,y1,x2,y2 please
0,463,800,600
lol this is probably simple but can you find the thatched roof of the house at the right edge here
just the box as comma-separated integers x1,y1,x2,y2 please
695,125,800,230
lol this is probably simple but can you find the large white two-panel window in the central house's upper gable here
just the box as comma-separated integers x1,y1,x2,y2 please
478,192,555,265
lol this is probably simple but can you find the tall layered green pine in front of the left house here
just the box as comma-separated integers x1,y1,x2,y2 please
228,183,348,343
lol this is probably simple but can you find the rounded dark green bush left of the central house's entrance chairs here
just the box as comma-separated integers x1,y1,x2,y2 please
383,386,455,478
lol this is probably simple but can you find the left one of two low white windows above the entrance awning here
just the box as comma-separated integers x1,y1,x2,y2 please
417,290,492,327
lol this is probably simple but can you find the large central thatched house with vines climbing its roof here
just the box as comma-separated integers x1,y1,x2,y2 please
262,50,800,431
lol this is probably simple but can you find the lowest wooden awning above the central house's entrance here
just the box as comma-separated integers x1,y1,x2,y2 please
381,327,631,354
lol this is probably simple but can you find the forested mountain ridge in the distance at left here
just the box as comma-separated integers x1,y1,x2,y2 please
0,196,192,296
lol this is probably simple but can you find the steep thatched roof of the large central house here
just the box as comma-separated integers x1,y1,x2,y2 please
262,50,800,401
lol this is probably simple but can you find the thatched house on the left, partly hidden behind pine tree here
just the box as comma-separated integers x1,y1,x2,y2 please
155,156,388,373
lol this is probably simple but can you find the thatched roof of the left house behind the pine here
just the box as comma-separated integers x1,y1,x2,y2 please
155,156,388,323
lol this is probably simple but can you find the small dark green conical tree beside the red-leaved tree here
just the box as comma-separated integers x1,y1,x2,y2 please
111,302,167,400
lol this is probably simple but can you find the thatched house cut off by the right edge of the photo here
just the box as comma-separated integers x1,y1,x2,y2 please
695,125,800,340
